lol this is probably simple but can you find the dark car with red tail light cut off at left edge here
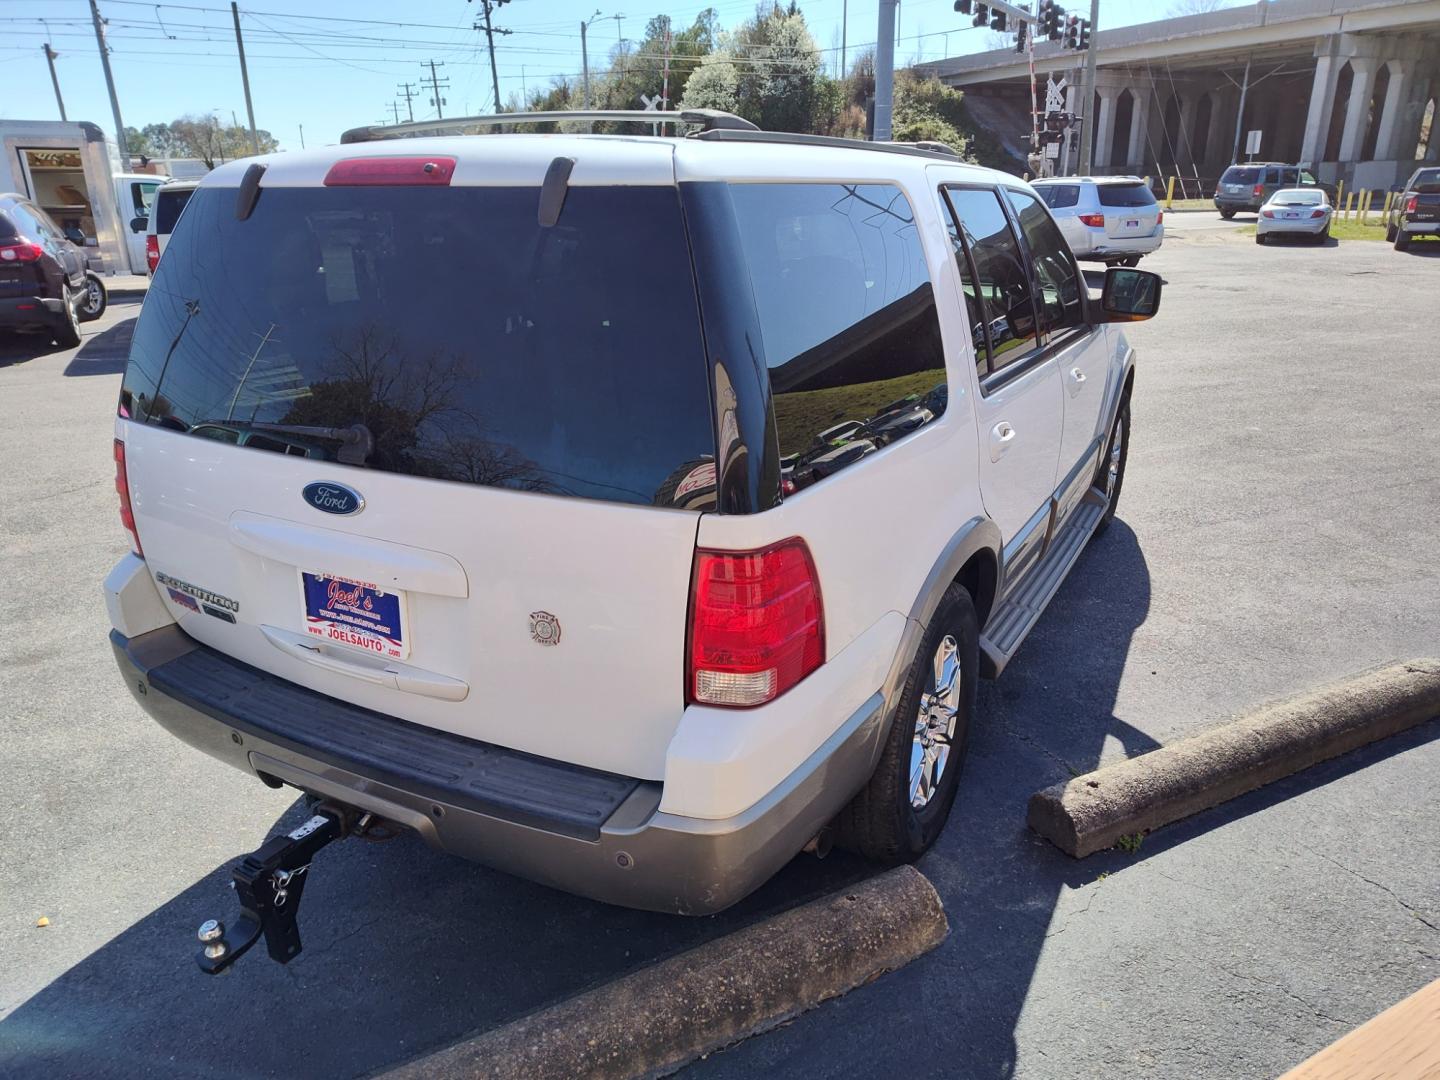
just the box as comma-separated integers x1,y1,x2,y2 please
0,194,107,348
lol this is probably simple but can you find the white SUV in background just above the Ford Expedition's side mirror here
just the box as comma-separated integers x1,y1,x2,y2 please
1034,176,1165,266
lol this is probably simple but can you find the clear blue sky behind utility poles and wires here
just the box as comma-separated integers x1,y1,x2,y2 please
0,0,1238,148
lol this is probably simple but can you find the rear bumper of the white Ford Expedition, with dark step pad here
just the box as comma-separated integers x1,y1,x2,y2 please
111,625,884,914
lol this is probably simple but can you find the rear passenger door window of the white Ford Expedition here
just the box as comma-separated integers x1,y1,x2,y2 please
945,187,1035,374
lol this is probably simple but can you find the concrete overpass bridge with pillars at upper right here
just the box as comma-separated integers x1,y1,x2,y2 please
922,0,1440,190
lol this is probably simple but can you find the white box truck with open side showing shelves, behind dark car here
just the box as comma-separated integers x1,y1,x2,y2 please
0,120,167,274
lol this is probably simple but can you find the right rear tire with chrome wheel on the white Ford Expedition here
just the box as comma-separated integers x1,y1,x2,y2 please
837,583,979,865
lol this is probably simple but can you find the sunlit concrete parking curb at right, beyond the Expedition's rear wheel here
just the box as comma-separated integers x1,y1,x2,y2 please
1028,660,1440,858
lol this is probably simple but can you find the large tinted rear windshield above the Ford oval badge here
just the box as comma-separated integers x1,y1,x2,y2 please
120,187,714,508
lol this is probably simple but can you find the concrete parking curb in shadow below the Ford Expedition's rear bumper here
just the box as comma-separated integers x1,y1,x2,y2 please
384,867,948,1080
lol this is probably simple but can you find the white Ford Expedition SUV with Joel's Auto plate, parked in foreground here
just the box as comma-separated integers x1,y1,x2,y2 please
105,112,1161,944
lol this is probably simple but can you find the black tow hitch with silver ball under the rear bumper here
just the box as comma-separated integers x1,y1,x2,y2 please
194,804,354,975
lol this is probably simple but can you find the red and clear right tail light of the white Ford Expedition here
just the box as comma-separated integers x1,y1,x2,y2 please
685,537,825,707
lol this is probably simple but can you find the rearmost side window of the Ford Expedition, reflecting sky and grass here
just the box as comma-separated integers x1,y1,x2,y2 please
730,183,949,491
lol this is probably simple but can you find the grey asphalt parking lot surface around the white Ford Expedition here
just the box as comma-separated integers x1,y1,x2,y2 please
0,215,1440,1079
